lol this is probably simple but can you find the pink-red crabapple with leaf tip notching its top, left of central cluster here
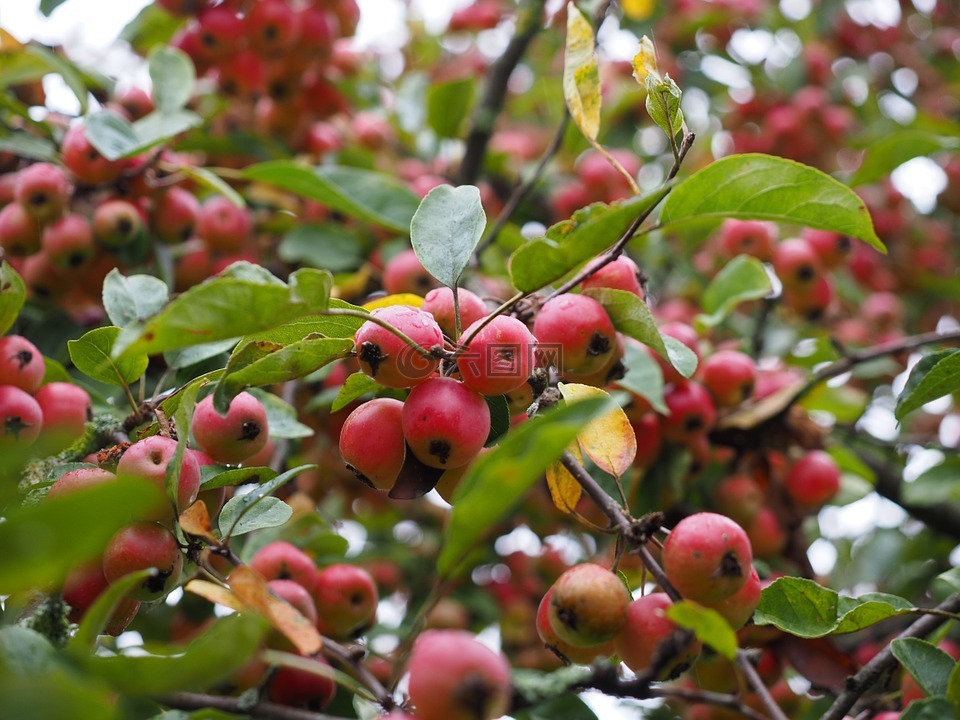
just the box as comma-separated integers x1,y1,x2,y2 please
190,392,270,465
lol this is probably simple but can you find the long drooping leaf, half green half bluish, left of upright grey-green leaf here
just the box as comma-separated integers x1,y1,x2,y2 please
243,160,418,233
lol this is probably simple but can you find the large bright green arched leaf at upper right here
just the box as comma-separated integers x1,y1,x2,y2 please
660,153,886,253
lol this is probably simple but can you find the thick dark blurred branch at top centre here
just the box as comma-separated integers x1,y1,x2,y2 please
459,0,546,185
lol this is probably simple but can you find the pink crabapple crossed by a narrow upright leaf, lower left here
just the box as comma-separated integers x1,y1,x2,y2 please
117,435,200,521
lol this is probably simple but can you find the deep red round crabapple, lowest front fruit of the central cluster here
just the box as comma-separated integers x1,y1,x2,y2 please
401,377,490,469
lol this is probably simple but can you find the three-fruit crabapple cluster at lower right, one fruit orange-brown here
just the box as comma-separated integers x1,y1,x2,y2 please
536,512,761,679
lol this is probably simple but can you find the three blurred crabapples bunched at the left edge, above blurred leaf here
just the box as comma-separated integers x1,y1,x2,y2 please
0,335,91,459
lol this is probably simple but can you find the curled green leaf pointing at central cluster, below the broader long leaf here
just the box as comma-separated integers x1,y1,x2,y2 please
214,335,353,414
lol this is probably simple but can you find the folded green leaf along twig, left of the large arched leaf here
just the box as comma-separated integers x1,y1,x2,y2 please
509,187,668,292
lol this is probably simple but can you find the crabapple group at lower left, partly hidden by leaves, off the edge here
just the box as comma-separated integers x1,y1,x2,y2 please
47,385,269,635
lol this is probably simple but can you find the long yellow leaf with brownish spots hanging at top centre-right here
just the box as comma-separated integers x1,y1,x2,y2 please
563,2,600,140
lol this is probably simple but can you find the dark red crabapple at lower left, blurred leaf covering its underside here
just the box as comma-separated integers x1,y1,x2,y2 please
103,522,183,601
